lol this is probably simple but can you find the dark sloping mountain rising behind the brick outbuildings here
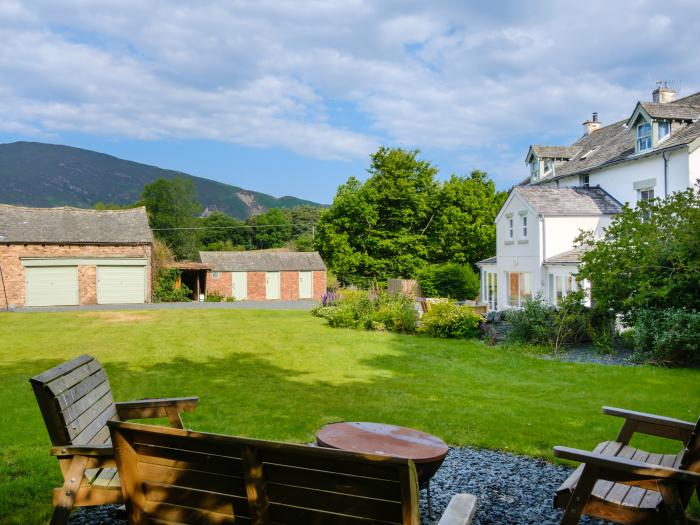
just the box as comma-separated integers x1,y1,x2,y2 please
0,142,321,219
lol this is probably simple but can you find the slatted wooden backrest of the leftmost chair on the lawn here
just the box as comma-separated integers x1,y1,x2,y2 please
29,355,117,446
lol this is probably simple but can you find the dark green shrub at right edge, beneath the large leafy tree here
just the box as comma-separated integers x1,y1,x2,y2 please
634,308,700,365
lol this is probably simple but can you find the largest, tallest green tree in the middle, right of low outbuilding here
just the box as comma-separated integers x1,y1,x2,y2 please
317,147,439,285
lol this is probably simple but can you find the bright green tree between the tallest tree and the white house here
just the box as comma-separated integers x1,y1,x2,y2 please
428,170,508,267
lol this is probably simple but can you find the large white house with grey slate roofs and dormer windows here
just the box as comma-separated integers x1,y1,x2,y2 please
477,84,700,310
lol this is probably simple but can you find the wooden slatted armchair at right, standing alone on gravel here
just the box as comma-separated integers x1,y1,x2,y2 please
554,407,700,525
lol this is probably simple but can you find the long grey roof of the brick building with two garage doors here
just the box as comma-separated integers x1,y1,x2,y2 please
0,204,153,244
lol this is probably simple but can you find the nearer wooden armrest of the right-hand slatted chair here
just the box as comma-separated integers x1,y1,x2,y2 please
554,447,700,483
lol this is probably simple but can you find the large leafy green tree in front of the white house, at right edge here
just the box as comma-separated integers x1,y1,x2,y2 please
578,183,700,323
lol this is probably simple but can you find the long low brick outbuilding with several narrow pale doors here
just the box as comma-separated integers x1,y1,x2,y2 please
199,250,326,301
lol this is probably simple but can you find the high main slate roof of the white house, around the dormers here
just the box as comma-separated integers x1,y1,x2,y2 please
534,92,700,184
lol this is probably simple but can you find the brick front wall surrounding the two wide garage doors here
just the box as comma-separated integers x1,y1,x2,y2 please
0,244,152,308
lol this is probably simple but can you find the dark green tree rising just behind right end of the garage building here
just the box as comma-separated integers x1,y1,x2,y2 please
139,176,202,259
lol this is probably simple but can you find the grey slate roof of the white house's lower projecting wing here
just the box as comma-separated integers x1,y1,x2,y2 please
513,186,622,217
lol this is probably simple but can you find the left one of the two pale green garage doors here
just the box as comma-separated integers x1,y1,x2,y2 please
24,266,78,306
